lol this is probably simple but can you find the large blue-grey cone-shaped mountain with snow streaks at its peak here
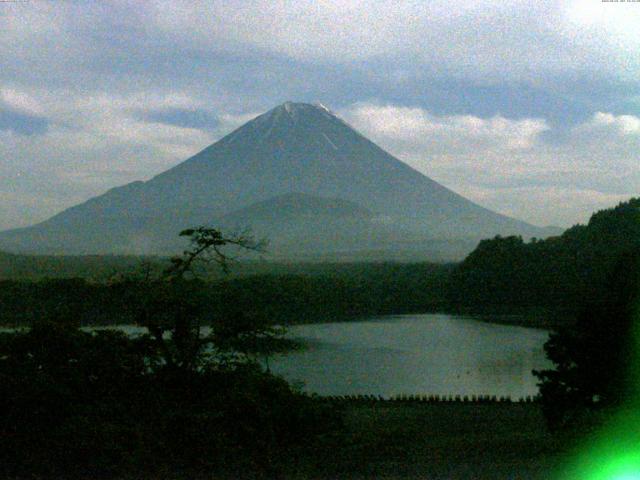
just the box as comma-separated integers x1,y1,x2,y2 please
0,102,559,257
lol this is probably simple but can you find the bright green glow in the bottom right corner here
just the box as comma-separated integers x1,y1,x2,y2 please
560,304,640,480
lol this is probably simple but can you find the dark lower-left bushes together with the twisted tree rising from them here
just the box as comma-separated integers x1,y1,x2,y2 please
0,227,337,478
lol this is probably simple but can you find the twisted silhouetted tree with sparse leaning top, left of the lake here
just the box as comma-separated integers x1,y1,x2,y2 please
134,226,272,370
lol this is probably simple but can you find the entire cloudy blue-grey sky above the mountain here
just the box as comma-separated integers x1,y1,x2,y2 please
0,0,640,229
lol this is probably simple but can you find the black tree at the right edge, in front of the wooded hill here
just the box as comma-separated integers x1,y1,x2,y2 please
534,250,640,428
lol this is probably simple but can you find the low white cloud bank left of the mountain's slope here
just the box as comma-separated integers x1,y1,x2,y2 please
0,90,255,229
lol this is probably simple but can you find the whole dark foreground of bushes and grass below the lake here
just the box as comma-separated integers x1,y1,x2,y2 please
0,318,566,479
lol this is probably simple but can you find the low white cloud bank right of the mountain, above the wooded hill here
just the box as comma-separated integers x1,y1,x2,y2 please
342,103,640,226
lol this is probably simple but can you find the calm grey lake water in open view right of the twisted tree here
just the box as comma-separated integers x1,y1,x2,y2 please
270,315,550,399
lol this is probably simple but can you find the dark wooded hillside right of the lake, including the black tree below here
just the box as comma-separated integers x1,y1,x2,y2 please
449,199,640,428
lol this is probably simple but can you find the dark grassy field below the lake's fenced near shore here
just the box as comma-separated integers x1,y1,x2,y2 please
280,402,569,480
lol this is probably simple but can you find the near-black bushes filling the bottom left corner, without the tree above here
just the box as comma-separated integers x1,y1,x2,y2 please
0,324,338,479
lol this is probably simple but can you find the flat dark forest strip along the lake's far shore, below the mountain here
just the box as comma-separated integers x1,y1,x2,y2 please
0,263,453,326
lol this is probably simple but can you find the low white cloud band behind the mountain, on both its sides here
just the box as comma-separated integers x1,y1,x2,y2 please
0,92,640,228
